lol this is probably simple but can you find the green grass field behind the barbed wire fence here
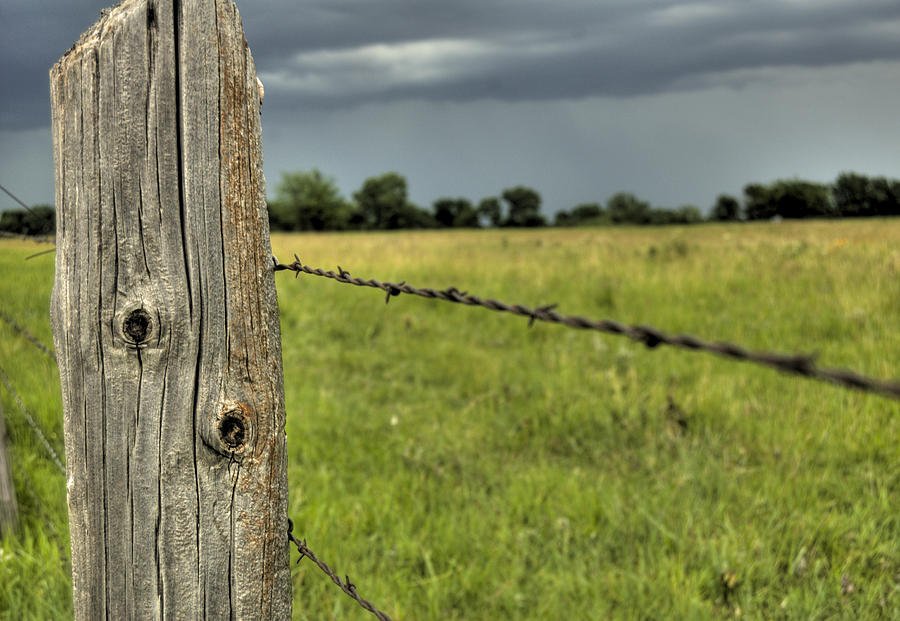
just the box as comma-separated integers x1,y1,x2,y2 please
0,220,900,620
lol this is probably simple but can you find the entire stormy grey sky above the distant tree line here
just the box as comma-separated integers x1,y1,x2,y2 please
0,0,900,215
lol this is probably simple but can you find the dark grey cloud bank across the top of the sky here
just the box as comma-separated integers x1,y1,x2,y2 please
0,0,900,130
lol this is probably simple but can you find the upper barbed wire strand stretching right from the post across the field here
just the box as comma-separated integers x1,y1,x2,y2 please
274,255,900,400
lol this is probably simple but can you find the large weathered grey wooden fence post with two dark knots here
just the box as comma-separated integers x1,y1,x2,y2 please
50,0,291,620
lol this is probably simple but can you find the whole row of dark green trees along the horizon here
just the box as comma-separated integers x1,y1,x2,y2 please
0,169,900,235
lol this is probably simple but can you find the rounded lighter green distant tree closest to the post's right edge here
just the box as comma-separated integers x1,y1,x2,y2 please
269,168,353,231
